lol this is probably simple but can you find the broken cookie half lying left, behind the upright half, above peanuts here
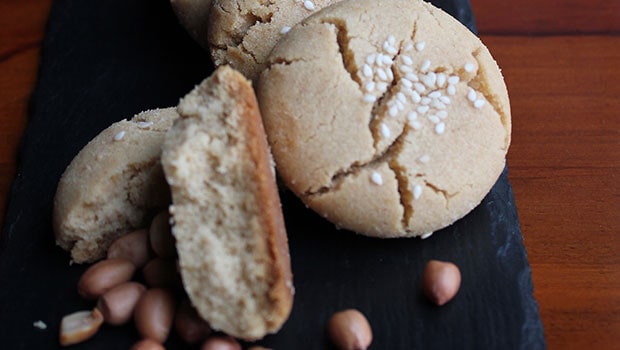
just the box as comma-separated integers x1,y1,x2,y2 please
52,108,178,263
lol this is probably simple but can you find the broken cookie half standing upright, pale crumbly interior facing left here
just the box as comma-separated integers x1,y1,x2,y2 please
162,66,293,340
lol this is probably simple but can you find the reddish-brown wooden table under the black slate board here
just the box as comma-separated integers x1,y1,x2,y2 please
0,0,620,349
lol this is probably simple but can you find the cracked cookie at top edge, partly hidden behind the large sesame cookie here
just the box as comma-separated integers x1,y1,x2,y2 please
208,0,339,80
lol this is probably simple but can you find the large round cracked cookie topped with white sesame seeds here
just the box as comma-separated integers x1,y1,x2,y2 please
257,0,511,237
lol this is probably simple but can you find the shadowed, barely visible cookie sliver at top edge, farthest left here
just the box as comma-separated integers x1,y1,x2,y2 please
170,0,211,49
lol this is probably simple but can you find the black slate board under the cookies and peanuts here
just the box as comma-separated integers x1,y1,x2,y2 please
0,0,545,349
